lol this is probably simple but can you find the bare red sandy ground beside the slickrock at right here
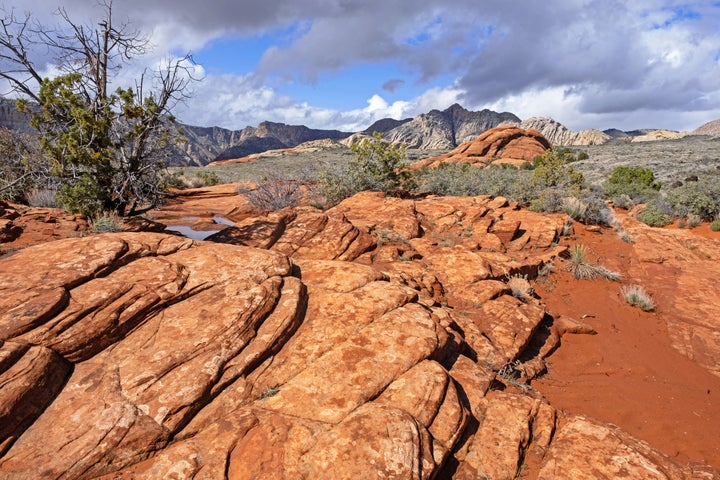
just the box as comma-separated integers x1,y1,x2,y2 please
532,224,720,467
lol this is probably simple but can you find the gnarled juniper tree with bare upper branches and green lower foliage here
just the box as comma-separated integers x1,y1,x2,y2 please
0,0,195,215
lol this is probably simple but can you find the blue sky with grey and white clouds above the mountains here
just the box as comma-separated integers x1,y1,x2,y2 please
0,0,720,131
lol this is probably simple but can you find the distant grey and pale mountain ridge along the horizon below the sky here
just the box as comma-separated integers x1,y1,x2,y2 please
0,97,708,166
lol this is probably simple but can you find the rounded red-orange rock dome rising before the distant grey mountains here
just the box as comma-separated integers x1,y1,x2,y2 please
410,125,551,170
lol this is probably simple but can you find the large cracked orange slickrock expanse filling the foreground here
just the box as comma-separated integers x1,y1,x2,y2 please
0,192,718,480
